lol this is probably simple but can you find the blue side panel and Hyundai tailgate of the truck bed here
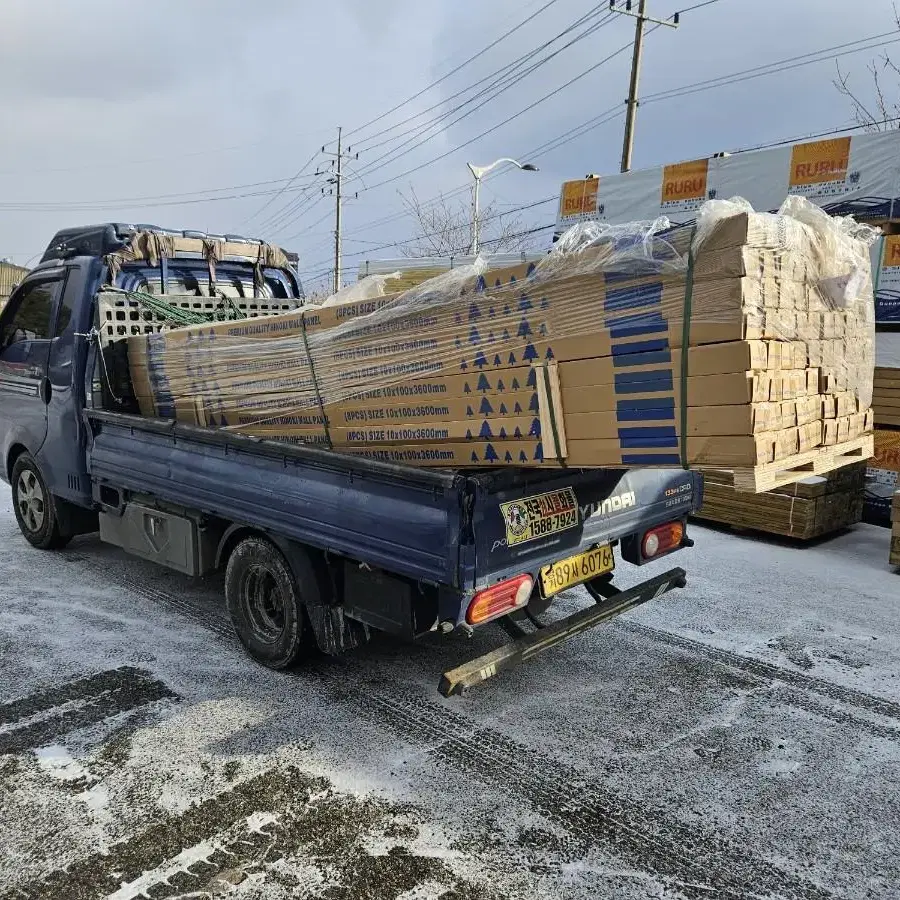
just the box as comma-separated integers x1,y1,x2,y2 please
86,410,702,592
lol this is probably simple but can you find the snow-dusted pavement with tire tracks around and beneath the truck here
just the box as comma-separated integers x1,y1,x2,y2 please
0,488,900,900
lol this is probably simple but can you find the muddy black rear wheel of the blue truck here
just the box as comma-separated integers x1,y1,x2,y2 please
225,537,308,669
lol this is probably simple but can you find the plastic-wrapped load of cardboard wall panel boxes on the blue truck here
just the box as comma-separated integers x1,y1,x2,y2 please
128,198,874,491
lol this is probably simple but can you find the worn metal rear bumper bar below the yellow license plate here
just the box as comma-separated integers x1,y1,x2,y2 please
438,568,687,697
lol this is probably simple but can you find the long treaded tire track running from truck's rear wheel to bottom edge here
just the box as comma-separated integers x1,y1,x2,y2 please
52,556,832,900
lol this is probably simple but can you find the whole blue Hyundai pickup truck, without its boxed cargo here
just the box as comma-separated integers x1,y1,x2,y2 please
0,224,702,695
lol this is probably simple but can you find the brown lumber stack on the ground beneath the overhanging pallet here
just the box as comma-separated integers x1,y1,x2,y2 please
696,464,866,540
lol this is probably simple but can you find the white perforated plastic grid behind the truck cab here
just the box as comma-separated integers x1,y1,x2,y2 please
97,291,298,347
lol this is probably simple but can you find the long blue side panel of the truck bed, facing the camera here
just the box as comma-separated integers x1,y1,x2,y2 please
89,413,463,585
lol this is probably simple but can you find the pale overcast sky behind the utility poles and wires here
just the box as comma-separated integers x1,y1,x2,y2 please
0,0,900,290
